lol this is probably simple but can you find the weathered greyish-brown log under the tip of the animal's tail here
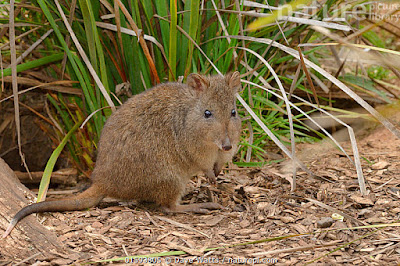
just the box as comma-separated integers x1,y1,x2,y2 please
0,158,71,263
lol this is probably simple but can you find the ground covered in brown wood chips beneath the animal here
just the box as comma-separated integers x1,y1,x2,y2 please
0,115,400,265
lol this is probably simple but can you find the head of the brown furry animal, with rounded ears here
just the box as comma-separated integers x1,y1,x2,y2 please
187,71,241,151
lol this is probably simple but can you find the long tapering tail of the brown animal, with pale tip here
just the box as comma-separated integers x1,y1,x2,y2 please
3,186,104,238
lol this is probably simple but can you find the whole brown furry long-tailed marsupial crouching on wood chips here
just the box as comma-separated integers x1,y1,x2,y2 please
3,72,241,237
